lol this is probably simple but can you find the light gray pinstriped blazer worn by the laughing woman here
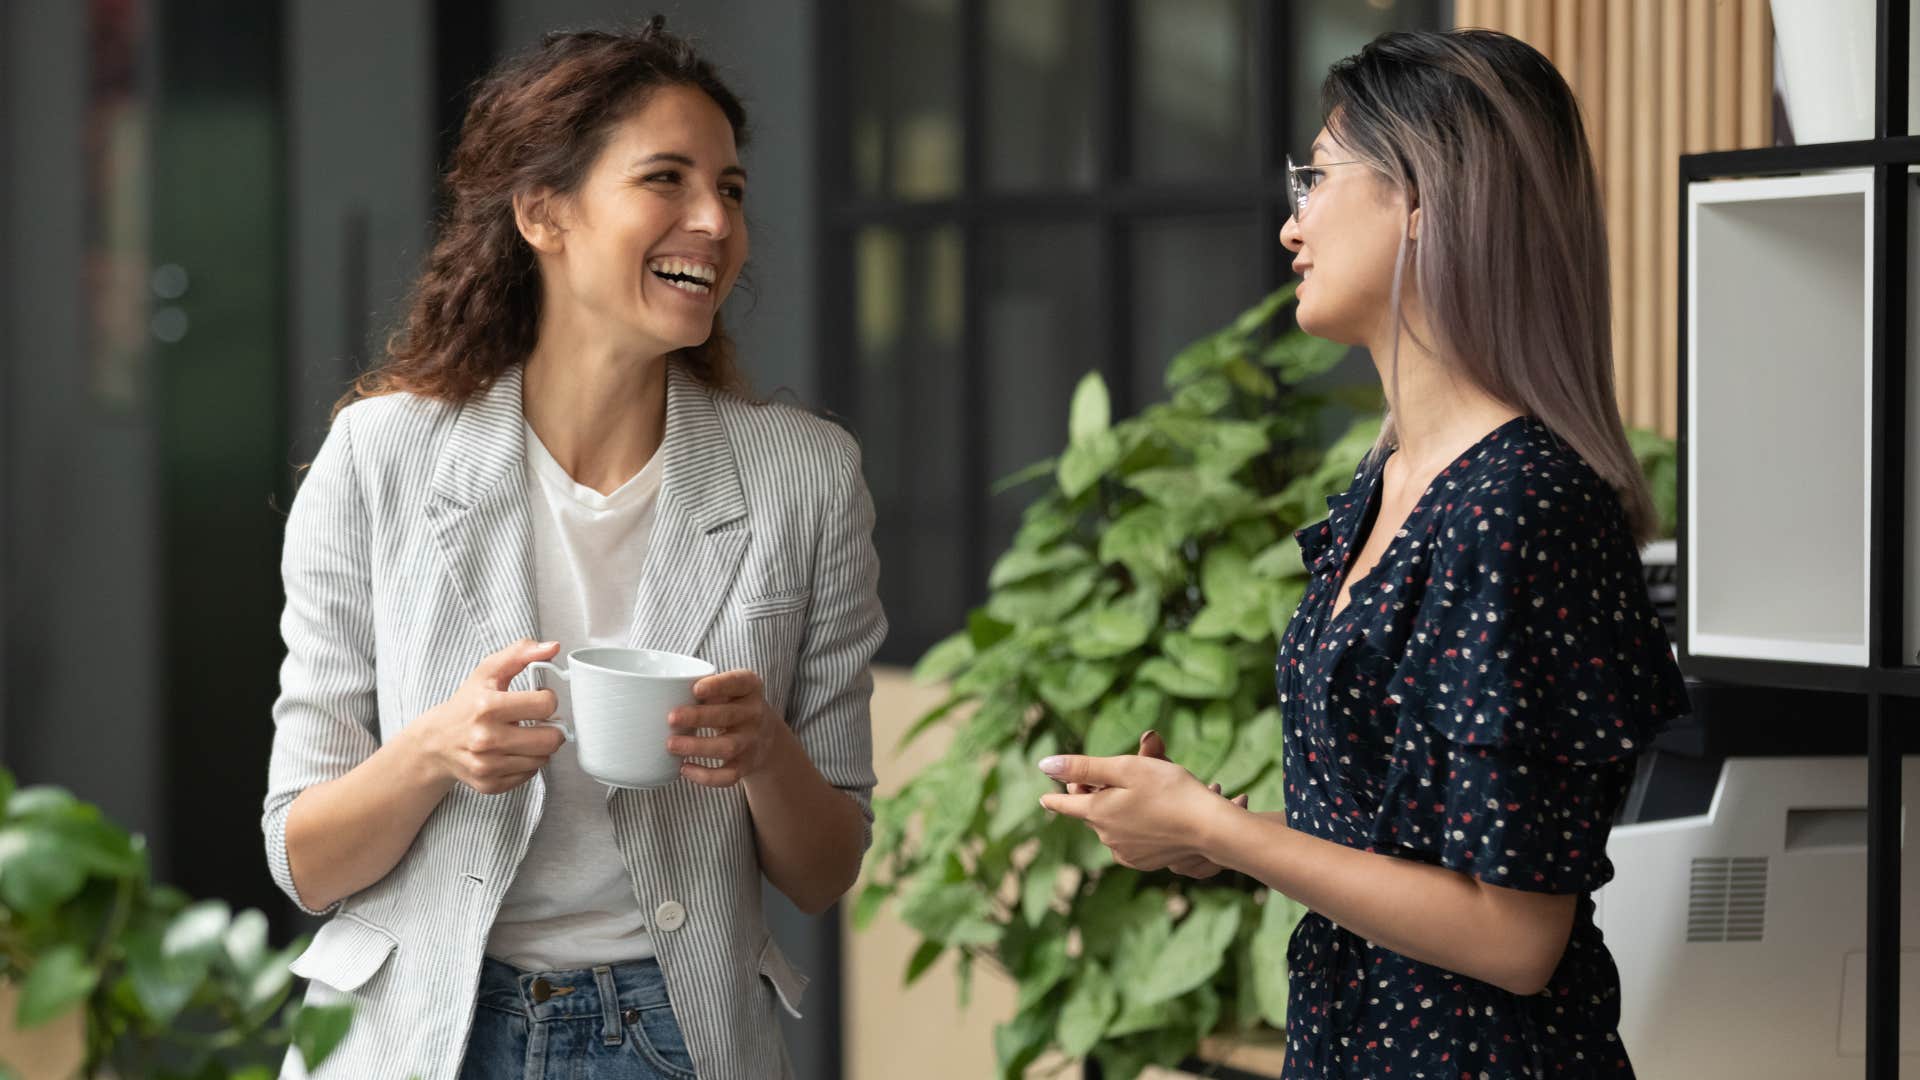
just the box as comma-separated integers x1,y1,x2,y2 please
261,363,887,1080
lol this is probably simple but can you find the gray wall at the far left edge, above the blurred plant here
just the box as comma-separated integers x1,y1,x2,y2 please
0,2,165,857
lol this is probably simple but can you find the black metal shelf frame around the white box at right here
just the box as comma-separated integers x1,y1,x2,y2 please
1678,0,1920,1080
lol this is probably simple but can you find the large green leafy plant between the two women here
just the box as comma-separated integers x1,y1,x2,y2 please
854,286,1380,1080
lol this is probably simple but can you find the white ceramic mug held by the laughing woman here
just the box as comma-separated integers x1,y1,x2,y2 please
526,646,716,788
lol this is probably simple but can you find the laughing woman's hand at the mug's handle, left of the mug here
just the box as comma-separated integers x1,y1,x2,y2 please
407,640,566,796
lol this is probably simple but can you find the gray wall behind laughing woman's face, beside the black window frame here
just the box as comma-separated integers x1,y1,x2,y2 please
499,0,818,405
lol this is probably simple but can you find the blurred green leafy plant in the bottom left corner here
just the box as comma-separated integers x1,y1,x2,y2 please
0,769,351,1080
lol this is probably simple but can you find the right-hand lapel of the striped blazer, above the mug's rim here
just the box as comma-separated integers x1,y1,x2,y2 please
628,361,751,653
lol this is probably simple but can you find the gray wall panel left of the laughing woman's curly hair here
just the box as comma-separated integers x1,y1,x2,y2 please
286,0,436,461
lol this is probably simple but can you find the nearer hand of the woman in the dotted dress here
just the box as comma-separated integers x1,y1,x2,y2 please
1041,755,1233,871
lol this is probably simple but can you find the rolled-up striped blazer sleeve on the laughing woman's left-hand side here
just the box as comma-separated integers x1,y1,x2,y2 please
261,409,380,915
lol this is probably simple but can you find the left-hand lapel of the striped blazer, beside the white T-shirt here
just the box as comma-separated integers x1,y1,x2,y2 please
426,367,538,661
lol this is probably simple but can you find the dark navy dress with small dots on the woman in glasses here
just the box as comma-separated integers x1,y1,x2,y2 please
1277,417,1688,1080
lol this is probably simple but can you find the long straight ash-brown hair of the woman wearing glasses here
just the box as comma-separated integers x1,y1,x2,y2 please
1321,31,1659,540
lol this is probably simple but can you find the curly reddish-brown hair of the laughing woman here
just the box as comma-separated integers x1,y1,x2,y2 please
334,15,747,415
